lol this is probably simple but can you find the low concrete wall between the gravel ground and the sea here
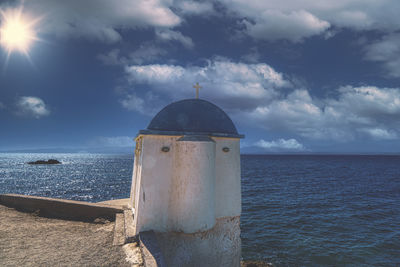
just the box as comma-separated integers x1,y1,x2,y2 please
0,194,123,222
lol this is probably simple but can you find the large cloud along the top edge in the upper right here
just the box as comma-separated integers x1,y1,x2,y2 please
220,0,400,42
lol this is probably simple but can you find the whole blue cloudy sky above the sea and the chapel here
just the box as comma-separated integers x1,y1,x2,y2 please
0,0,400,153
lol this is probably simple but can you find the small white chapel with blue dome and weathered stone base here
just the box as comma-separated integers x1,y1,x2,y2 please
130,99,244,266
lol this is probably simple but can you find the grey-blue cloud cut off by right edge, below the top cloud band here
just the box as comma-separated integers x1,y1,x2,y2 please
365,33,400,78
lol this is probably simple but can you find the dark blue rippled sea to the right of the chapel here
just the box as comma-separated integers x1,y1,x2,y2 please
241,155,400,266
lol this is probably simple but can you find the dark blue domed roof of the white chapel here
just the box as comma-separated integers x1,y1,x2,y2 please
139,99,243,138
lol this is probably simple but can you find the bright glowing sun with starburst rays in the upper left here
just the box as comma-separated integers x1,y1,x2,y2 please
0,7,38,55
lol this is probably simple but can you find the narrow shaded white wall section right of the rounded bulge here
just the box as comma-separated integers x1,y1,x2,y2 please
213,137,242,218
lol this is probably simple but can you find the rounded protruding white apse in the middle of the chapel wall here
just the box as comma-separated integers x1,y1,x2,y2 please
169,139,215,233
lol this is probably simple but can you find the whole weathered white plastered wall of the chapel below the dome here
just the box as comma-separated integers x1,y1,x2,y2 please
131,135,241,236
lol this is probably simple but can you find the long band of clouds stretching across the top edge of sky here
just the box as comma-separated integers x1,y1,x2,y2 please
5,0,400,43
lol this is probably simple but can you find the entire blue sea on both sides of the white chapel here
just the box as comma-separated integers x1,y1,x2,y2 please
0,153,400,266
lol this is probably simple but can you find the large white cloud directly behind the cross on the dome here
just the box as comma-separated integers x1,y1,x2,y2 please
125,58,291,109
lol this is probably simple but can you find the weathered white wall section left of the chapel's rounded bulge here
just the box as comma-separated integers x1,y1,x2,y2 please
131,135,177,233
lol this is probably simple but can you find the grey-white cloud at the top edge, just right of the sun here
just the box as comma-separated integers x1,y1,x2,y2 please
24,0,181,43
